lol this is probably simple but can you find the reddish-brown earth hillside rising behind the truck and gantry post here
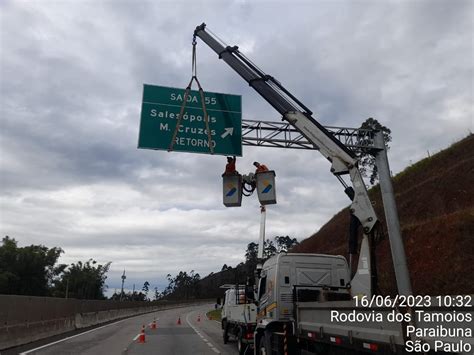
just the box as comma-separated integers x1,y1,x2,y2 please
293,134,474,295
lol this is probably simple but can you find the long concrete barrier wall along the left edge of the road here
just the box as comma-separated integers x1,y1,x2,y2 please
0,295,212,350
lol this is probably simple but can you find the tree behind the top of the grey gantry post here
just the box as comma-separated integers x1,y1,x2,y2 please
358,117,392,185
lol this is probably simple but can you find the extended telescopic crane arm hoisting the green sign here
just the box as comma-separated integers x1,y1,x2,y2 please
194,23,377,234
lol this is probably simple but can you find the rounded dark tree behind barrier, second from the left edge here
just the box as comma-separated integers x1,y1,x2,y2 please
54,259,111,300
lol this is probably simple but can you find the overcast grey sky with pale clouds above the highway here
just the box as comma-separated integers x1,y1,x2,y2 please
0,0,474,290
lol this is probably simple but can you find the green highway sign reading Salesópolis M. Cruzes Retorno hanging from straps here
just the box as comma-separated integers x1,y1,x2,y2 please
138,84,242,156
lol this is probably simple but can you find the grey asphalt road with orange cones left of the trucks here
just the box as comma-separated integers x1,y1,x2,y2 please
13,304,244,355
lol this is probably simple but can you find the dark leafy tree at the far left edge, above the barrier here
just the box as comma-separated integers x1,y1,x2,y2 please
0,236,66,296
